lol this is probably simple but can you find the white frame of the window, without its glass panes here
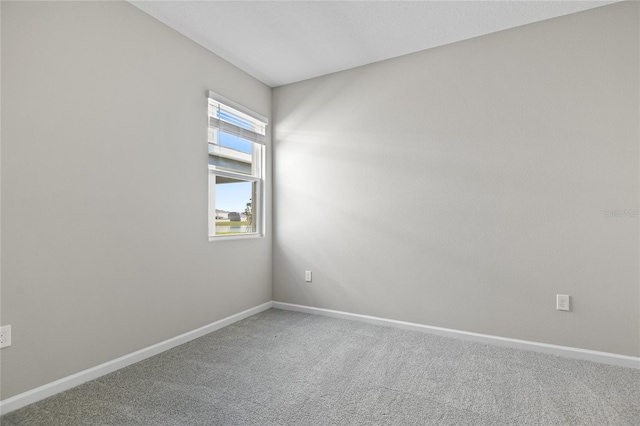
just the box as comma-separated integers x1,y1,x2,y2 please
207,91,268,241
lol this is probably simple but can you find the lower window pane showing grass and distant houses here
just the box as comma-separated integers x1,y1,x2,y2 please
214,176,256,235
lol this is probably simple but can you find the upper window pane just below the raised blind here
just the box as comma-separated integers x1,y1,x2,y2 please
209,131,262,175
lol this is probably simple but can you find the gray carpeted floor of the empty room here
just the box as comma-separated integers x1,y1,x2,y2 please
0,309,640,426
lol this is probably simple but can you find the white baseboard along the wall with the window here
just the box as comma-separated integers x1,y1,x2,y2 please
0,302,273,414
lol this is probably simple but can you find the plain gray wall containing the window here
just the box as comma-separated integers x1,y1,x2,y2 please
1,1,272,399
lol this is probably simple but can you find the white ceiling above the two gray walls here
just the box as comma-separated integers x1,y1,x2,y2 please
130,0,615,87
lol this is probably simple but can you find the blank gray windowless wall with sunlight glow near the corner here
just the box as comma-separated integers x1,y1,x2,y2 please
273,2,640,356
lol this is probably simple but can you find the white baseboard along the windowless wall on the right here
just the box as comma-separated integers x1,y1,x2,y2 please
273,301,640,369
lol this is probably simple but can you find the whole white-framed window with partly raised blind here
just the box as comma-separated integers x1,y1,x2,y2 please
208,92,267,240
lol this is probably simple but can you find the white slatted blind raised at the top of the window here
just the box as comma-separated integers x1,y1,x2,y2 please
209,92,268,145
